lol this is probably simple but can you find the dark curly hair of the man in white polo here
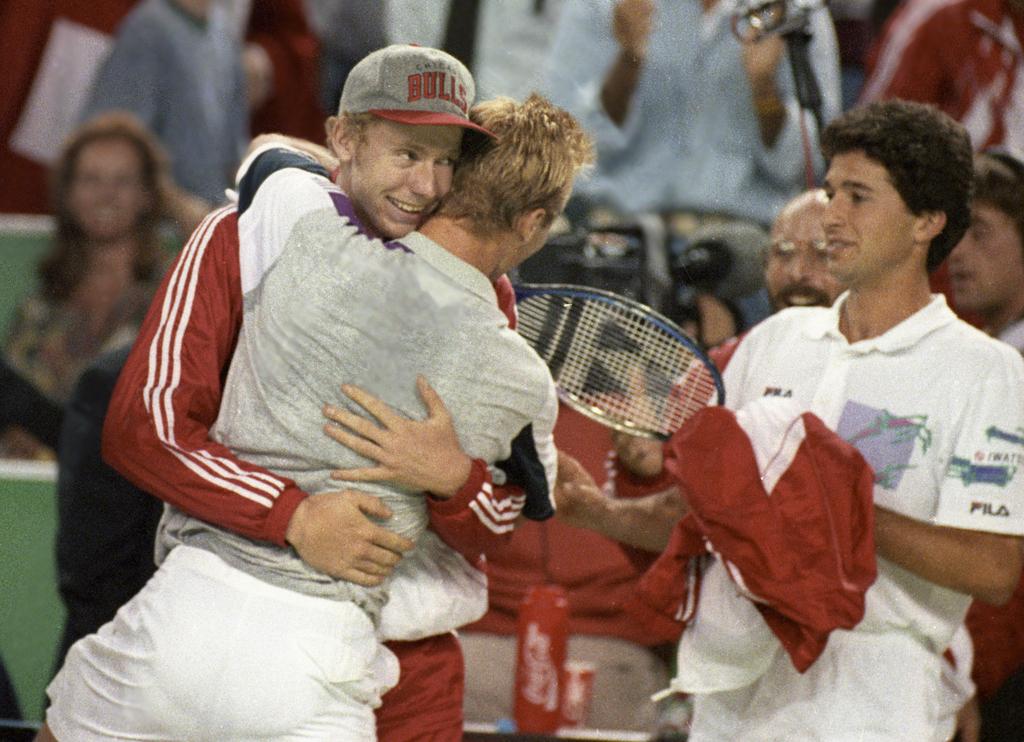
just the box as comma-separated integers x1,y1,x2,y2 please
821,100,974,270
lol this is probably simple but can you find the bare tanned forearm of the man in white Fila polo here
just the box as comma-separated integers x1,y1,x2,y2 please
874,508,1022,605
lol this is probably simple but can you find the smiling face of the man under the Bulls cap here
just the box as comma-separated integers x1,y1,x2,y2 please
331,119,463,239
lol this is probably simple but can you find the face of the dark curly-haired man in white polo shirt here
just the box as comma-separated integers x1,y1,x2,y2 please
824,150,945,290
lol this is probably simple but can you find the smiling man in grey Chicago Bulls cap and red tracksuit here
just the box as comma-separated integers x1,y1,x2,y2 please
37,47,585,740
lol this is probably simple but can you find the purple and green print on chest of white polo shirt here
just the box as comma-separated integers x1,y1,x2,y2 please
836,401,932,489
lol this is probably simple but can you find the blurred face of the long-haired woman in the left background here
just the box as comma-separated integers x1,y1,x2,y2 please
68,138,153,244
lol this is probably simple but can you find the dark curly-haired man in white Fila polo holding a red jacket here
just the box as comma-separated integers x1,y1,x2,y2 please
681,101,1024,742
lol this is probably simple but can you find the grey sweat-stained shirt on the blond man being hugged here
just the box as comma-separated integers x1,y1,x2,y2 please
158,149,557,620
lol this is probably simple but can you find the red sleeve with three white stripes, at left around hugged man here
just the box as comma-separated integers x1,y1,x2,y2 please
102,207,306,544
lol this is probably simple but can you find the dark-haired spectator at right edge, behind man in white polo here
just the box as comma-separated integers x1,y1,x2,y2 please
949,151,1024,742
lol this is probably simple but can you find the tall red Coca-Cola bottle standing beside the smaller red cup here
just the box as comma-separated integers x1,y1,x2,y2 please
512,584,569,733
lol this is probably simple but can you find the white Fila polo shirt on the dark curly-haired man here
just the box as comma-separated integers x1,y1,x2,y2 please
725,296,1024,651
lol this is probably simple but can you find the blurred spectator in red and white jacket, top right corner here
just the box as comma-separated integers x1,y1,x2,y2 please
861,0,1024,149
